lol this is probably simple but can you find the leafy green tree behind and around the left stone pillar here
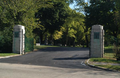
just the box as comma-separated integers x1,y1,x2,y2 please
0,0,40,52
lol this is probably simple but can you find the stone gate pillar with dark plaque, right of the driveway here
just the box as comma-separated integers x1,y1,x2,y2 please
90,25,104,58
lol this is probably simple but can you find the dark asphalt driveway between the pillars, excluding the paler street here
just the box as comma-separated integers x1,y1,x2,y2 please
0,47,89,68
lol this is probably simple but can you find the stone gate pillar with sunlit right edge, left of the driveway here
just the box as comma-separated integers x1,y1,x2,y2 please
13,25,25,54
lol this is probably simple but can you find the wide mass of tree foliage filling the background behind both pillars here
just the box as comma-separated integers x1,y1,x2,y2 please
0,0,120,51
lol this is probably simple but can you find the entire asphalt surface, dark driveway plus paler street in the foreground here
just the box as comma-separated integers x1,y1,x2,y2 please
0,47,120,78
